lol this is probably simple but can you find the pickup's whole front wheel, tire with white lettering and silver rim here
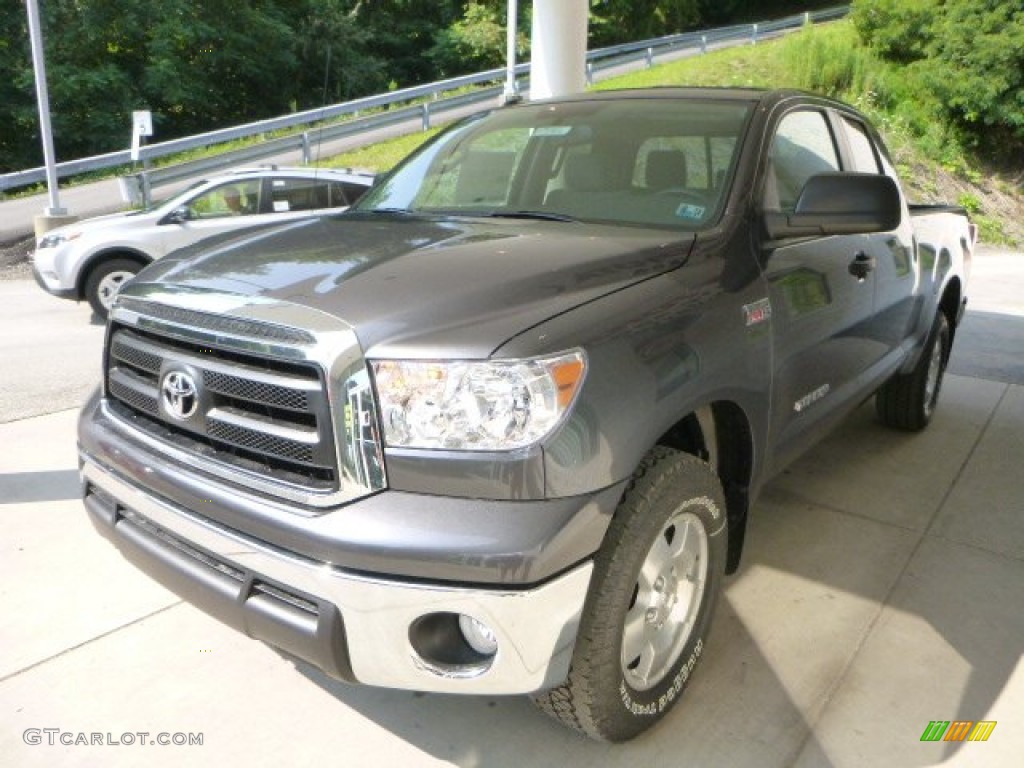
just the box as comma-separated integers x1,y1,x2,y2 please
535,446,727,741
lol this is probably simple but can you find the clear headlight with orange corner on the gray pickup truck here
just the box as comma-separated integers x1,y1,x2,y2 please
372,349,587,451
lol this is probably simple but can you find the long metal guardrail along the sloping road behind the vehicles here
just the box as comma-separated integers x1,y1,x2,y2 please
0,5,849,193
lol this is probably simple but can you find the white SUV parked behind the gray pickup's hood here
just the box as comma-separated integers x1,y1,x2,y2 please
33,167,374,319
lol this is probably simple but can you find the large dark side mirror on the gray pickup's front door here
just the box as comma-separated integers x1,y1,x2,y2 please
765,173,903,240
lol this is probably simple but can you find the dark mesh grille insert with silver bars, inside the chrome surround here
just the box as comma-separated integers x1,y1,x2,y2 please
105,325,340,493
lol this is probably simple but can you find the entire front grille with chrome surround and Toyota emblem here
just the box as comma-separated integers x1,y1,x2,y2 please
104,290,385,507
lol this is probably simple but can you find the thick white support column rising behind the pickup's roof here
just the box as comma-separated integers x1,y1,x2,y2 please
529,0,590,99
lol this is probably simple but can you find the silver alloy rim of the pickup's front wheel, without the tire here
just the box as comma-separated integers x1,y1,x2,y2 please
622,512,708,691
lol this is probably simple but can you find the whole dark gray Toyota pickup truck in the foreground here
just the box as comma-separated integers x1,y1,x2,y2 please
79,89,975,740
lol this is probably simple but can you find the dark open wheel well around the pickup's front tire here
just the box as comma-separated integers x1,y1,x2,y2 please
656,400,754,573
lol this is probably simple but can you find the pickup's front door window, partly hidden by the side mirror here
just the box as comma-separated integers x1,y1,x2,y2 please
764,110,840,211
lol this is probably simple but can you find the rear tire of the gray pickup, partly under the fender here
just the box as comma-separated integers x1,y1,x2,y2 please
874,309,952,432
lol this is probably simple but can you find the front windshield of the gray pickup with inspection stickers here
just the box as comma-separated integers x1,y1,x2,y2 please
356,97,751,229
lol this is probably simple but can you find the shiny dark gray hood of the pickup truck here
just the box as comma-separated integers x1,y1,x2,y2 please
132,212,694,358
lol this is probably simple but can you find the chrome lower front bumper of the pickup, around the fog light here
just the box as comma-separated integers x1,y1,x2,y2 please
82,455,593,694
